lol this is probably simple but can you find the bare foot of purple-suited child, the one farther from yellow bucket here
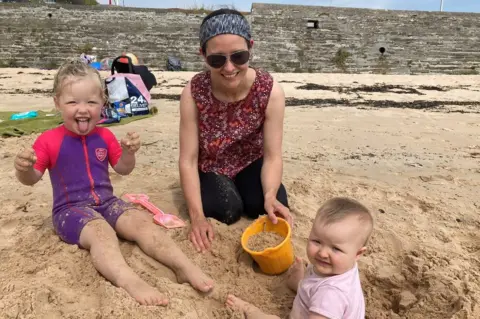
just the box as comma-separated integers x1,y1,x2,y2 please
118,275,168,306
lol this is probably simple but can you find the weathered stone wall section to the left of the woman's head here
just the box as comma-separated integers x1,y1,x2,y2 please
0,3,206,69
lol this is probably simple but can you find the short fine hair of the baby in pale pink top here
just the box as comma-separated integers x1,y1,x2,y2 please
315,197,373,244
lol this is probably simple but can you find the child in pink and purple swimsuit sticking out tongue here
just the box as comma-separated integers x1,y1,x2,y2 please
15,60,213,305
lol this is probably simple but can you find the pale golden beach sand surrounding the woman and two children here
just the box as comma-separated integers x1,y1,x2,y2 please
0,69,480,319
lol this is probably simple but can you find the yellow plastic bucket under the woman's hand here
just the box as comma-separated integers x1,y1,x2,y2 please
242,215,294,275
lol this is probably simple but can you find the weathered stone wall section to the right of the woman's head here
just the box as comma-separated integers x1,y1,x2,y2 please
252,4,480,74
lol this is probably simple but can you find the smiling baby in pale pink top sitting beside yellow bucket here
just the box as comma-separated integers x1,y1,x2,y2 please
226,197,373,319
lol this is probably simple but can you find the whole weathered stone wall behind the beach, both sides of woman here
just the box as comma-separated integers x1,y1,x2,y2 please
0,3,480,74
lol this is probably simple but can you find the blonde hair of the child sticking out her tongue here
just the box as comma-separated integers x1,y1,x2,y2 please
53,59,105,99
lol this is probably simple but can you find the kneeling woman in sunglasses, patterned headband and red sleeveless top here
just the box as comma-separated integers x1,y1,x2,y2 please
179,9,292,251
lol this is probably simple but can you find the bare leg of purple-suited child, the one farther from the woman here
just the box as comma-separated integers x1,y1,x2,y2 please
79,219,168,305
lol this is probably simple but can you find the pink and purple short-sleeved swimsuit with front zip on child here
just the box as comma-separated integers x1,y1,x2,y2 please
33,125,133,244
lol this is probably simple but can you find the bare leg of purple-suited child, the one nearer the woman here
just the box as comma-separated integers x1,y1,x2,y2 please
115,209,213,292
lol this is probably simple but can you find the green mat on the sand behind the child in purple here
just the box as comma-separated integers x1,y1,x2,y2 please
0,111,152,138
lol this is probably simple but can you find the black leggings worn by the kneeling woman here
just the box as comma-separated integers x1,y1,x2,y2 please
199,158,288,225
